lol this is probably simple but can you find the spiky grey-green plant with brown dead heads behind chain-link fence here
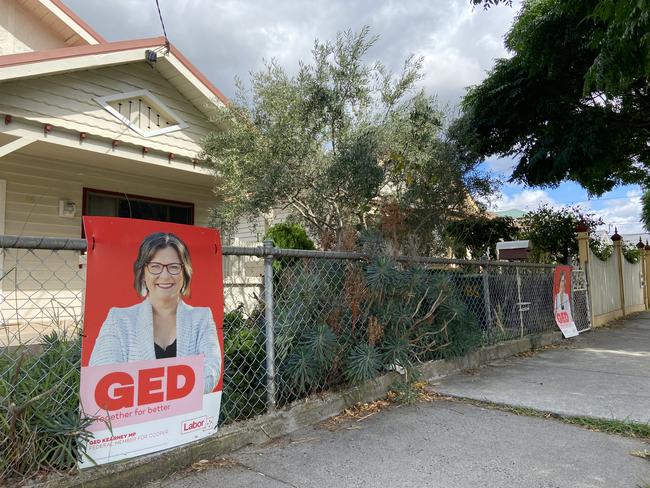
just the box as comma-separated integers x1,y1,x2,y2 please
275,250,481,403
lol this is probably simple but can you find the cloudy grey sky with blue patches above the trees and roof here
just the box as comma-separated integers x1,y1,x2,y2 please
64,0,642,233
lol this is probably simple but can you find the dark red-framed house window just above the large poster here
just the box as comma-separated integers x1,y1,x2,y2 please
83,188,194,225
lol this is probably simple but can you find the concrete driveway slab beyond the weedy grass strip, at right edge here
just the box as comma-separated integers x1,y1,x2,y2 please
434,313,650,423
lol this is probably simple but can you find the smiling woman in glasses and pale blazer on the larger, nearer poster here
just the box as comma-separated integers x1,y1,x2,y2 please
90,232,221,393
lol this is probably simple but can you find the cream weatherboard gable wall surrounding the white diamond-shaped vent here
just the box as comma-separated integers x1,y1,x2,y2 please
0,61,215,158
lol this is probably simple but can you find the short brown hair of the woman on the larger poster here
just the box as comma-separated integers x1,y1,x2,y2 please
133,232,192,296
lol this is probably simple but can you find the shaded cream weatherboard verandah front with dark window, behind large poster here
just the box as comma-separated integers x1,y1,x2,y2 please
0,133,216,344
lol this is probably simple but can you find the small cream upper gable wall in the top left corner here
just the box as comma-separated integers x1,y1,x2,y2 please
0,0,66,56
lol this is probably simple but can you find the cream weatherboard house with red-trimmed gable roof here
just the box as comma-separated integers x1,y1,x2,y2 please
0,0,258,332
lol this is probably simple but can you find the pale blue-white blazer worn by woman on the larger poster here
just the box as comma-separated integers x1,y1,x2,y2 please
90,300,221,393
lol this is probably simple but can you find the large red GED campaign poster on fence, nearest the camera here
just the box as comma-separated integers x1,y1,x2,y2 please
80,217,224,468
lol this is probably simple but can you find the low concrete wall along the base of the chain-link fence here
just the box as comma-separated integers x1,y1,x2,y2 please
39,332,562,488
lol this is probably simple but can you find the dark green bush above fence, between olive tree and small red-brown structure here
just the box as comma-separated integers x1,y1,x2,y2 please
446,215,519,259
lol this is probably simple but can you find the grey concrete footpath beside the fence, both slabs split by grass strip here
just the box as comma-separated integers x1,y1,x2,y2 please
149,314,650,488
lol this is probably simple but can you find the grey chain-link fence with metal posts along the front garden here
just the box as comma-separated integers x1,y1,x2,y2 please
0,236,589,482
